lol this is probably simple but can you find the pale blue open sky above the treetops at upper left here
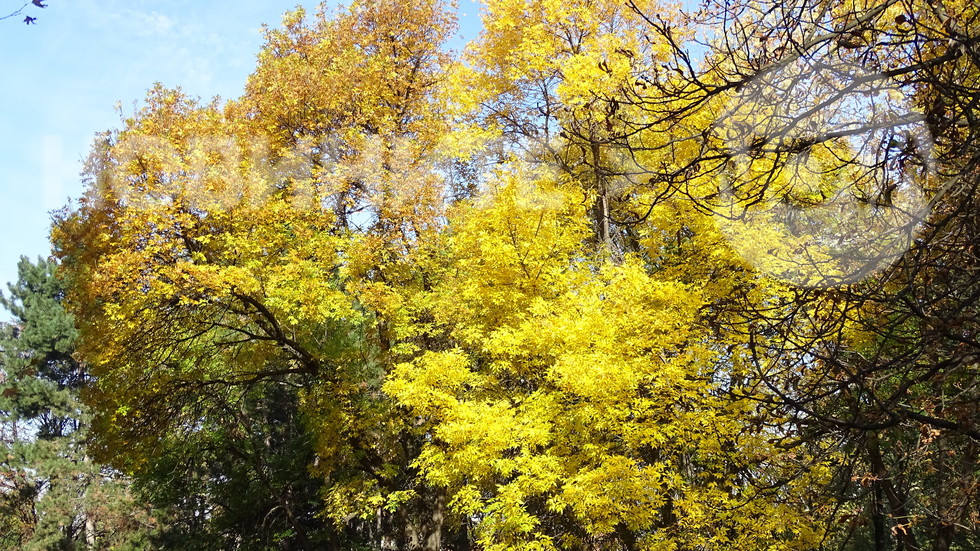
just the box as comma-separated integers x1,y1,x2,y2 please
0,0,479,302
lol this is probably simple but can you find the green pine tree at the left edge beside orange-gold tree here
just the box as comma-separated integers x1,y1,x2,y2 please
0,258,153,550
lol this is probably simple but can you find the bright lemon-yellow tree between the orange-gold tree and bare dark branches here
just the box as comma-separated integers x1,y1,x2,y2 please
360,2,856,549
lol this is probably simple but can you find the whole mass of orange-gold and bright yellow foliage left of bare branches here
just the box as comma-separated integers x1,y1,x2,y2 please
55,0,859,551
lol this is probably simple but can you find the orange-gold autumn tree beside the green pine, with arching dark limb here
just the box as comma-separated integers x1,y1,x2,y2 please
55,1,478,549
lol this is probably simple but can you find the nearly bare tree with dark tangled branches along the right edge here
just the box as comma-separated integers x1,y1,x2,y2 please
568,2,980,549
